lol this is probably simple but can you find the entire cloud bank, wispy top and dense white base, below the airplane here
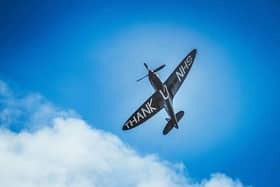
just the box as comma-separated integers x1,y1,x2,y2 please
0,81,247,187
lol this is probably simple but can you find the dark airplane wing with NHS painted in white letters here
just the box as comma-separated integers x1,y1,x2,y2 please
164,49,196,99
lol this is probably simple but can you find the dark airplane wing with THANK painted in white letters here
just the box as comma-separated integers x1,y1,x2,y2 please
122,91,164,130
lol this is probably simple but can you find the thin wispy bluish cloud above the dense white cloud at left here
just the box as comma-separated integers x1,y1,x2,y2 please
0,80,79,131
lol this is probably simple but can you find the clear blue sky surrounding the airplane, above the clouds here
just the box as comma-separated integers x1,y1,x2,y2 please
0,1,280,186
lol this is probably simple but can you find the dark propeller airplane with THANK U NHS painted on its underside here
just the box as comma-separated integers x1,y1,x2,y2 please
122,49,197,135
